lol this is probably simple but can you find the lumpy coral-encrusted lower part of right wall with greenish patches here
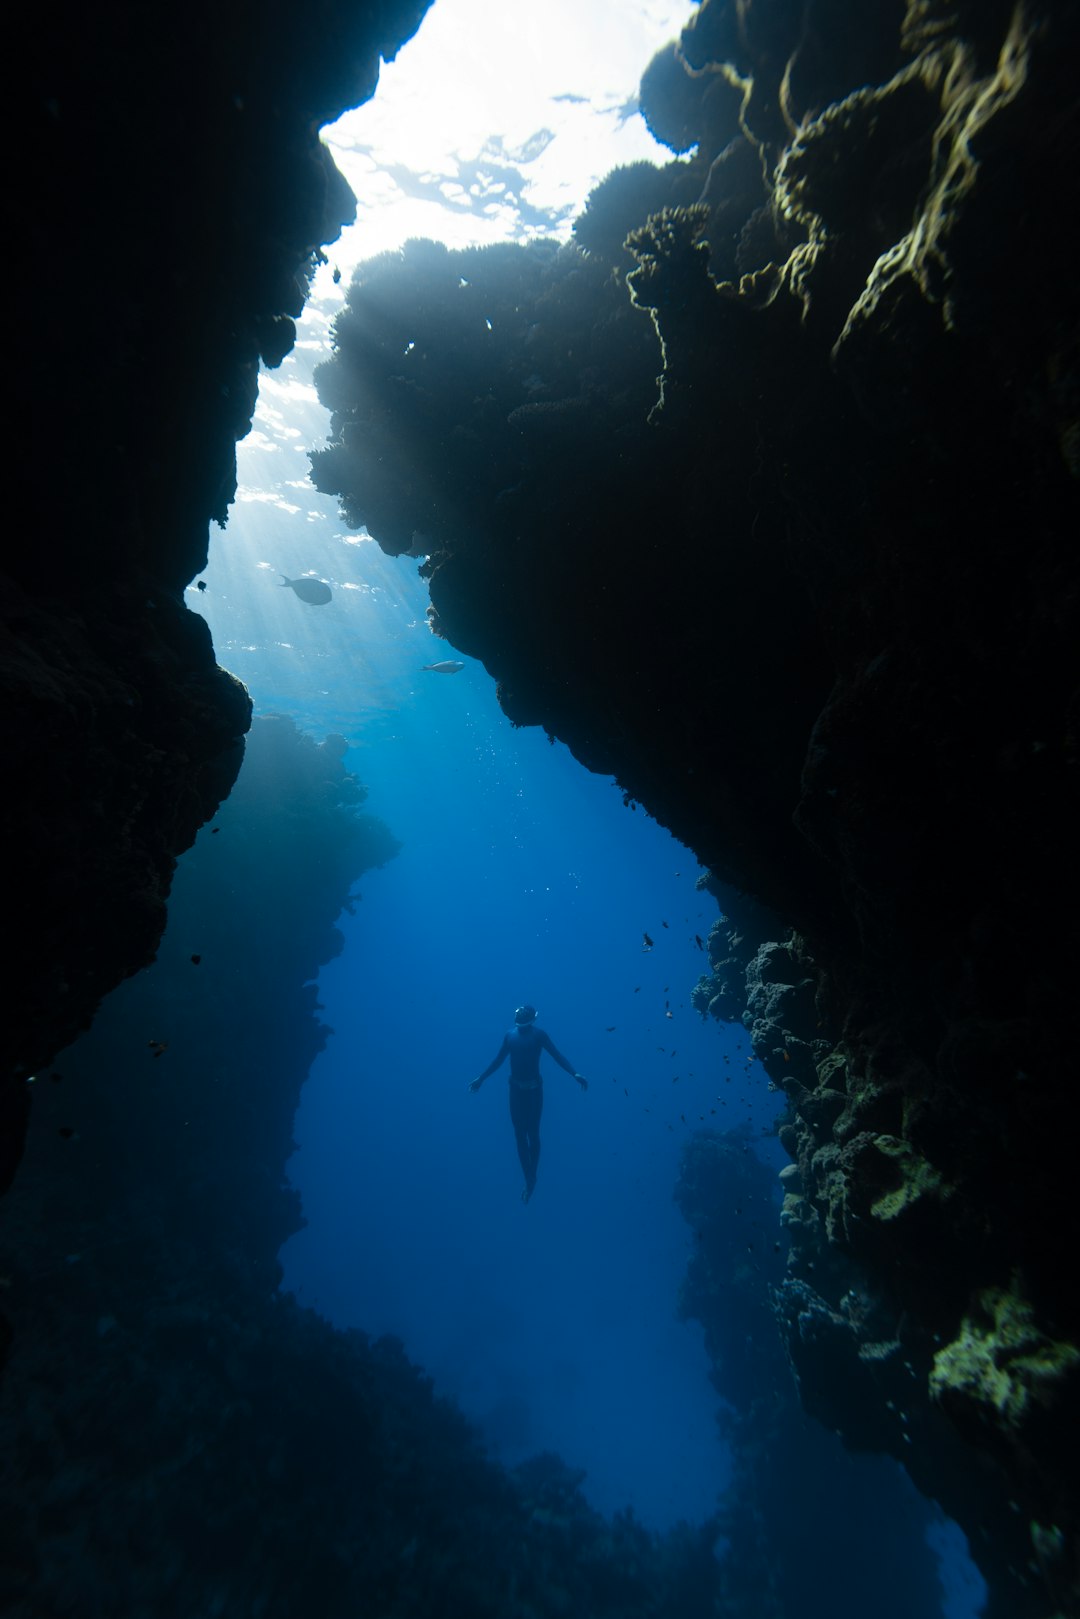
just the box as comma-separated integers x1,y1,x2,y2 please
695,906,1080,1619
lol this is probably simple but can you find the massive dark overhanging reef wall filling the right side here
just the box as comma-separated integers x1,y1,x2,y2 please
307,0,1080,1619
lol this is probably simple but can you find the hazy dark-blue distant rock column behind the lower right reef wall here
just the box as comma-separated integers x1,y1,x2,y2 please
675,1132,941,1619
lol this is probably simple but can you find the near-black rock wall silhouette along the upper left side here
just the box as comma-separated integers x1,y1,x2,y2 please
0,0,426,1188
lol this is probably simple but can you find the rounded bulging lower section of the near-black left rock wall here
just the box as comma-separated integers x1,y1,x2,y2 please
0,572,251,1190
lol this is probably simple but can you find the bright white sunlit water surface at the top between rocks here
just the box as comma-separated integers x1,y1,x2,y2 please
324,0,695,268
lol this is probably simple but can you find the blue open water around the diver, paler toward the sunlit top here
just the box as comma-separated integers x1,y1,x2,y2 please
188,312,981,1593
